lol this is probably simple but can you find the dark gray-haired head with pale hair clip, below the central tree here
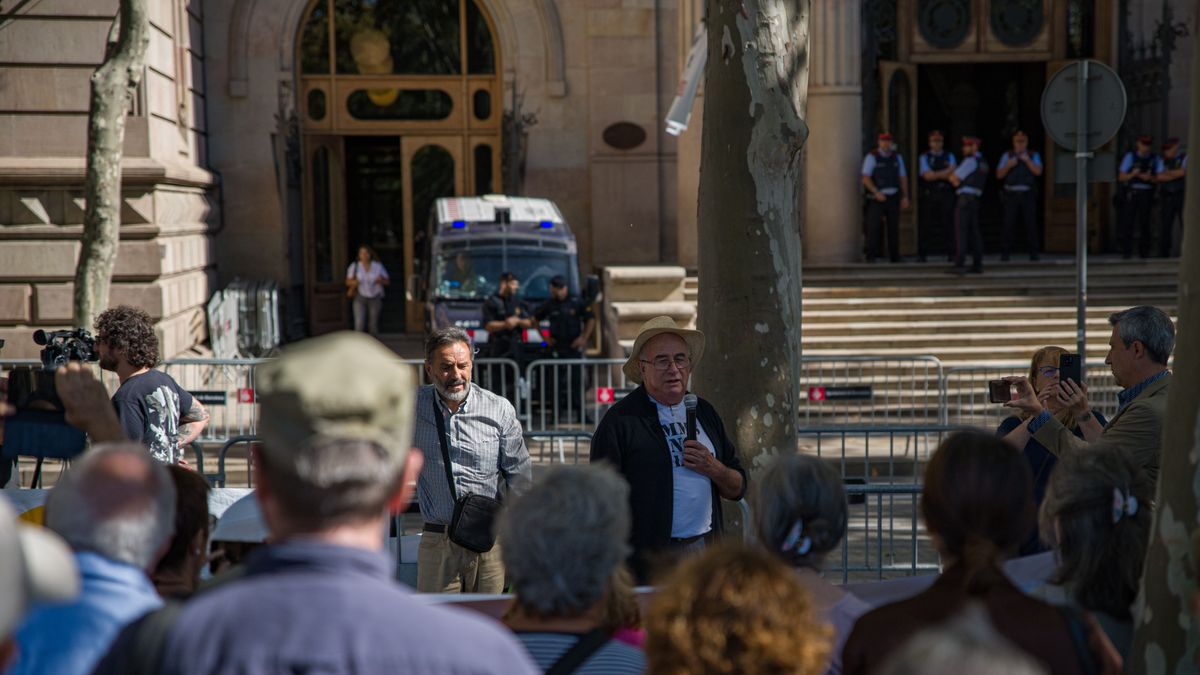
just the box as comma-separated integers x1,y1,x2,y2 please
751,453,847,567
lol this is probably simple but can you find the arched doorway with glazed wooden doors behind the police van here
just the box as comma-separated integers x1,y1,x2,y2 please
304,0,503,334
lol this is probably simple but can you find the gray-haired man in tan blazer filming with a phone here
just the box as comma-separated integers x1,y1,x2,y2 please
1006,305,1175,482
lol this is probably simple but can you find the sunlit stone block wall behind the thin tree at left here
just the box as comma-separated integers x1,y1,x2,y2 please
0,0,218,358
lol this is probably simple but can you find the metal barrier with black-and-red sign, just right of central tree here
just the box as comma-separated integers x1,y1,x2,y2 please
797,356,946,425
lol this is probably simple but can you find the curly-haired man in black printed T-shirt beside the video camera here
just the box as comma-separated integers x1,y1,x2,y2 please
96,305,209,465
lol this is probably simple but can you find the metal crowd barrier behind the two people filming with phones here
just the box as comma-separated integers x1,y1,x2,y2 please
942,362,1121,430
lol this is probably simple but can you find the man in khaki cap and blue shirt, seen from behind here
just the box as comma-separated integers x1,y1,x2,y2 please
88,331,536,675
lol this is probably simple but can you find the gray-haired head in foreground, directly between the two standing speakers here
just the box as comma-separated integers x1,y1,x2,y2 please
498,466,630,617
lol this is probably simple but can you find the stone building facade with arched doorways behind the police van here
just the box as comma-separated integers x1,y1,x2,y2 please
0,0,1196,345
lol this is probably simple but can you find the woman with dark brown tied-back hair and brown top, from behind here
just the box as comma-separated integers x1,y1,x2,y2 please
842,431,1121,675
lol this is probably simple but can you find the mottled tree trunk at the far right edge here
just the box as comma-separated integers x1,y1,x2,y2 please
1126,19,1200,675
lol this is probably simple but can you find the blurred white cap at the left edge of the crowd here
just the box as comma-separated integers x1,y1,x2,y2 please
0,497,79,639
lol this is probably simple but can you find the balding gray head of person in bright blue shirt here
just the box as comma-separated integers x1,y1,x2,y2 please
46,443,175,569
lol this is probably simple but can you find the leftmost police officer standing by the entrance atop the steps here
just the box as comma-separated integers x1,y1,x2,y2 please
862,133,908,263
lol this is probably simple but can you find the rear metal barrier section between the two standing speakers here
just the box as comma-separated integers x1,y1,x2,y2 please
524,359,636,431
